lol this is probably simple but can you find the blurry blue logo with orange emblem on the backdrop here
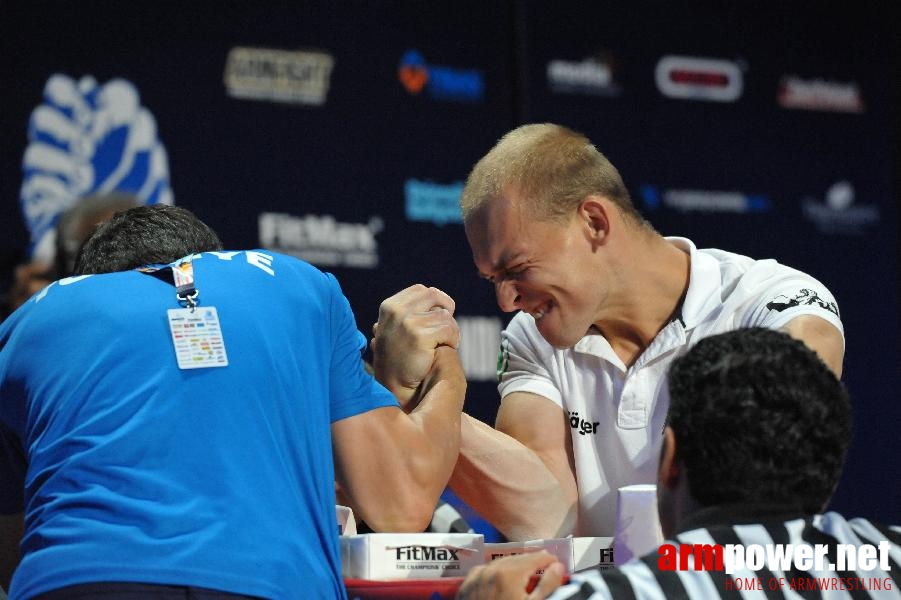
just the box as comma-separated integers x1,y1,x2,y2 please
397,50,485,103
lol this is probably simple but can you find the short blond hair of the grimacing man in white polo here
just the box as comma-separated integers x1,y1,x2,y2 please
460,123,644,224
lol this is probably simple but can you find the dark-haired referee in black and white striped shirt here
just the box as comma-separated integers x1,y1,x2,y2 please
458,328,901,600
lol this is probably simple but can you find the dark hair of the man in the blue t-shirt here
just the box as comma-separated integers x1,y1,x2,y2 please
75,204,222,275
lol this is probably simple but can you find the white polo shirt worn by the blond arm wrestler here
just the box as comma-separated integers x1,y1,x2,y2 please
498,237,844,536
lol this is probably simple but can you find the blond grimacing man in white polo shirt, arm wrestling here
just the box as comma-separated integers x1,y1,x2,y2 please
372,124,844,540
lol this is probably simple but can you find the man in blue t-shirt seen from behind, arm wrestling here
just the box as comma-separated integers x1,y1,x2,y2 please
0,205,466,600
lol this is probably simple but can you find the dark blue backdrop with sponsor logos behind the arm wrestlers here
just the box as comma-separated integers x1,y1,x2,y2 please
0,0,901,523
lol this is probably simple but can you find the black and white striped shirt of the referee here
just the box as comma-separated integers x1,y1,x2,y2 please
551,507,901,600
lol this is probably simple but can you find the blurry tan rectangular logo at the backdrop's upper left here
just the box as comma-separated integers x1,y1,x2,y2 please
223,47,335,106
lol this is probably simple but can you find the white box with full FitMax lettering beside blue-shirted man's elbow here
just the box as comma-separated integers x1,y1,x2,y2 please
340,533,485,581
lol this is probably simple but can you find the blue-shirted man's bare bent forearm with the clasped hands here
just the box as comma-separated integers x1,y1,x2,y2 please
332,286,466,531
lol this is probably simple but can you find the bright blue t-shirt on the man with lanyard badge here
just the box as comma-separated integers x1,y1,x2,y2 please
0,250,397,598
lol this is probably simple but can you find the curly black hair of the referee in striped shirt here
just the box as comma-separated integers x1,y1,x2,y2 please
667,328,851,513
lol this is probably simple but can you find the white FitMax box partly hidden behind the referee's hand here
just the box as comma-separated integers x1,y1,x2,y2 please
485,537,613,573
